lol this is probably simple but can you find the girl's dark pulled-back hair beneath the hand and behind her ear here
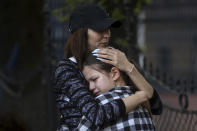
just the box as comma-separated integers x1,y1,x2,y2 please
83,54,133,86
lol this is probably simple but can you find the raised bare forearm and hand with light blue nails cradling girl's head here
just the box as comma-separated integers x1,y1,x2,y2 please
93,48,154,99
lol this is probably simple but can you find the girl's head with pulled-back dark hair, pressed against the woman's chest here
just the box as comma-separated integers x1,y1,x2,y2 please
83,55,129,95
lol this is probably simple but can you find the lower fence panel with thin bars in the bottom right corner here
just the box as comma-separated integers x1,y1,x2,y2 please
153,104,197,131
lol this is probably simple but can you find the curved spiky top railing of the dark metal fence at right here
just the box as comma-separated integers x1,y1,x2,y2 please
142,55,197,94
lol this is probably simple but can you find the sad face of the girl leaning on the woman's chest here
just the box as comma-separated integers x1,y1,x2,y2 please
83,66,115,96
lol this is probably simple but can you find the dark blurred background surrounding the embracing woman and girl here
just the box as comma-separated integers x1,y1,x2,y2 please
0,0,197,131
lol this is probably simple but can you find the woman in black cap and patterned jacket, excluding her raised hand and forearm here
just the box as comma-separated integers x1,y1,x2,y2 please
55,4,162,130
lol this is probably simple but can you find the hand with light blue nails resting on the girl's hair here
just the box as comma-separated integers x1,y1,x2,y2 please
93,48,133,72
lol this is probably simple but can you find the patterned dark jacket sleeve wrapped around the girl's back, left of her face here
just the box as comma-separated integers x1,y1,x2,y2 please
55,63,126,127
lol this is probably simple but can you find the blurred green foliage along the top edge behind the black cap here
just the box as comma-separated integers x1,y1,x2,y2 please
53,0,152,22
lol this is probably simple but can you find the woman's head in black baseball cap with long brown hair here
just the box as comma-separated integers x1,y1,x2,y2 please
65,3,121,68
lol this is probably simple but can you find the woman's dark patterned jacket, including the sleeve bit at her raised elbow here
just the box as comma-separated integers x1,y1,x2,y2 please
54,59,162,130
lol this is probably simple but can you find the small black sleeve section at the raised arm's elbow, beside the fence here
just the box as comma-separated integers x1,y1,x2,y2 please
149,89,163,115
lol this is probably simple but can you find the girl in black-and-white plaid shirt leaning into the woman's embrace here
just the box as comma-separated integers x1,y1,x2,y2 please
78,55,160,131
